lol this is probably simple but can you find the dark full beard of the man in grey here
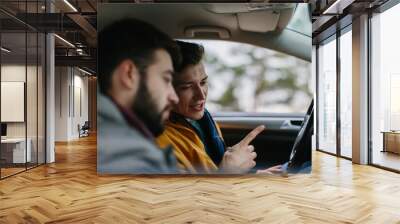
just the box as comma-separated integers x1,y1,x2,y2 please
132,79,167,137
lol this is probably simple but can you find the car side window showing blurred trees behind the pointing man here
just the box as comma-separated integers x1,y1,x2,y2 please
181,40,312,113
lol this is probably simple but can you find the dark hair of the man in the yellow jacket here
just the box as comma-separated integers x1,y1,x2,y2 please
176,40,204,73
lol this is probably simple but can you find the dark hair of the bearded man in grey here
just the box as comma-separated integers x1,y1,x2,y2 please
98,19,181,93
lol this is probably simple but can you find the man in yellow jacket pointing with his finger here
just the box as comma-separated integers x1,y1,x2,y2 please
157,41,264,173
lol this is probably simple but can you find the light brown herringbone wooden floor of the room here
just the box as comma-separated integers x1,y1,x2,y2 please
0,134,400,224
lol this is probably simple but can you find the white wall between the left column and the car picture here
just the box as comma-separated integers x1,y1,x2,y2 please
55,67,88,141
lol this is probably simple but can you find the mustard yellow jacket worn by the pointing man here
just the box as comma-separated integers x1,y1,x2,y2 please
157,121,222,173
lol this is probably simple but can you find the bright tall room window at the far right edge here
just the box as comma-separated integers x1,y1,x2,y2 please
371,1,400,170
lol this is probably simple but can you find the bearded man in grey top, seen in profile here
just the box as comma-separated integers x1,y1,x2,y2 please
97,19,180,174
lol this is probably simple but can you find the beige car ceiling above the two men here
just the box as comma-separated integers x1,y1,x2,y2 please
97,3,312,61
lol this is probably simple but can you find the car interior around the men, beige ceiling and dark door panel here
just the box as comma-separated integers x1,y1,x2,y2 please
98,3,312,171
